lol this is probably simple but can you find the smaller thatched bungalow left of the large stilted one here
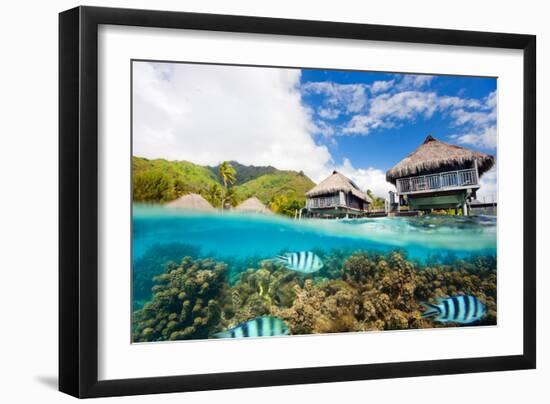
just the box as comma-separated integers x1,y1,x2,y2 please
306,171,372,218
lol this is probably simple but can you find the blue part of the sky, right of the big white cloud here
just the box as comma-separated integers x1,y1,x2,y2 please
301,70,497,170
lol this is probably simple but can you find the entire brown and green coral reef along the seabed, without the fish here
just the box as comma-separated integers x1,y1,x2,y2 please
133,250,497,341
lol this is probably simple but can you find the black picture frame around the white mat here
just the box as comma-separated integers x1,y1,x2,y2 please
59,7,536,398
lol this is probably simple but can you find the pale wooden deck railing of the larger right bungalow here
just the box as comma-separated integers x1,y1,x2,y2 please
396,168,479,194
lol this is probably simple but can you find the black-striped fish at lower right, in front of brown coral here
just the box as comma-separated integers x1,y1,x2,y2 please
421,295,487,324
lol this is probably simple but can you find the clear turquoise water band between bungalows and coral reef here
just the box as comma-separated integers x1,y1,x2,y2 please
133,205,496,262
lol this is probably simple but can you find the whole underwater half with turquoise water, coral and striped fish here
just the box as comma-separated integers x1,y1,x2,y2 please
132,205,497,342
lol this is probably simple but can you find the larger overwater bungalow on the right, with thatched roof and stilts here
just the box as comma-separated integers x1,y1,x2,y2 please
386,136,495,215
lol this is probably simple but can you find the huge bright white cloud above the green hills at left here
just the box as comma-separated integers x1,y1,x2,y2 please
133,62,331,179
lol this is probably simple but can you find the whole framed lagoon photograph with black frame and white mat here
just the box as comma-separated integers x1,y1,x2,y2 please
59,7,536,397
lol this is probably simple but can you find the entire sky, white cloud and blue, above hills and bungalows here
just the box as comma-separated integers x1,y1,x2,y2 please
132,61,497,199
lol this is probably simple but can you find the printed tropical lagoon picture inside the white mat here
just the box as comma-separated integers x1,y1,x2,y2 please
128,60,498,343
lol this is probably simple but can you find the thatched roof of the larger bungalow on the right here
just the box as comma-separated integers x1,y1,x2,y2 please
386,136,495,184
